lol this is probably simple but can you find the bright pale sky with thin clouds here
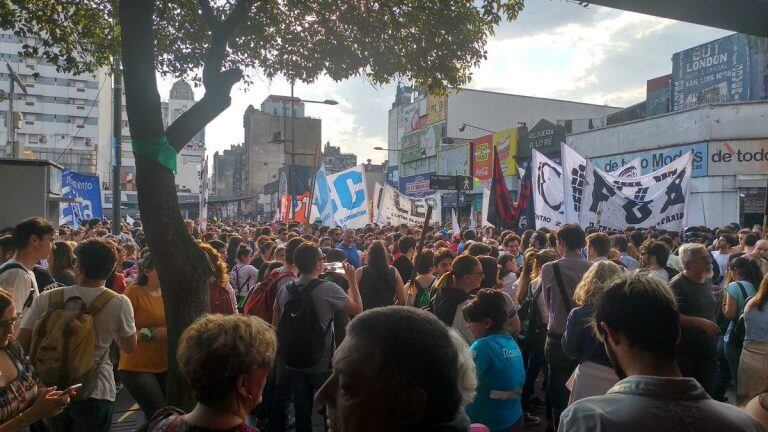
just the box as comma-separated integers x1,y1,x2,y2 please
159,0,732,163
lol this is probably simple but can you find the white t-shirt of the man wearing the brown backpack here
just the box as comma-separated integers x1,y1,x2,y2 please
21,285,136,401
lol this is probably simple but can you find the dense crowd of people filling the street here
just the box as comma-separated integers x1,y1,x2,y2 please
0,218,768,432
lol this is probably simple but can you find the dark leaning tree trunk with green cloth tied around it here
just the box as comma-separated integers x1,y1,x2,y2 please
120,0,211,410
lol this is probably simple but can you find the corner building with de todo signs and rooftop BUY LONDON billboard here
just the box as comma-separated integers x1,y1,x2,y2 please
566,34,768,227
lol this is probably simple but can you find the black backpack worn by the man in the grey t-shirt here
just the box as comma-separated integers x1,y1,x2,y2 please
277,279,333,369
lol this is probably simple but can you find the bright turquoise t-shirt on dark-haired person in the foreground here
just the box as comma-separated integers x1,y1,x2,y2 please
466,333,525,431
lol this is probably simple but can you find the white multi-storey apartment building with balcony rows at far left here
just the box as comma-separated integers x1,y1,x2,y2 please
0,30,112,174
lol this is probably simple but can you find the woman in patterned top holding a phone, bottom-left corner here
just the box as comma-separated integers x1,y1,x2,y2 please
0,288,77,432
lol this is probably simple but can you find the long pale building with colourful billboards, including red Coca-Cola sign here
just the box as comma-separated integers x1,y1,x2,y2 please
386,87,621,223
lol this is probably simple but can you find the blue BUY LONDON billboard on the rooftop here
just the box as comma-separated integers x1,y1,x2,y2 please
672,33,750,111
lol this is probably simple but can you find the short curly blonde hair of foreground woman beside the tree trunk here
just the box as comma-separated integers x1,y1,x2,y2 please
176,314,277,405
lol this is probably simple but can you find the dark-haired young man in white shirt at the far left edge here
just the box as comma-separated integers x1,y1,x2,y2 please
0,217,56,313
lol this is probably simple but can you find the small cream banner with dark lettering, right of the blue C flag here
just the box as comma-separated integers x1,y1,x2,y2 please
373,183,442,225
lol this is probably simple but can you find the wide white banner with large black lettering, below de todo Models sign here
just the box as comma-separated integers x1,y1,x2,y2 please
579,152,693,231
